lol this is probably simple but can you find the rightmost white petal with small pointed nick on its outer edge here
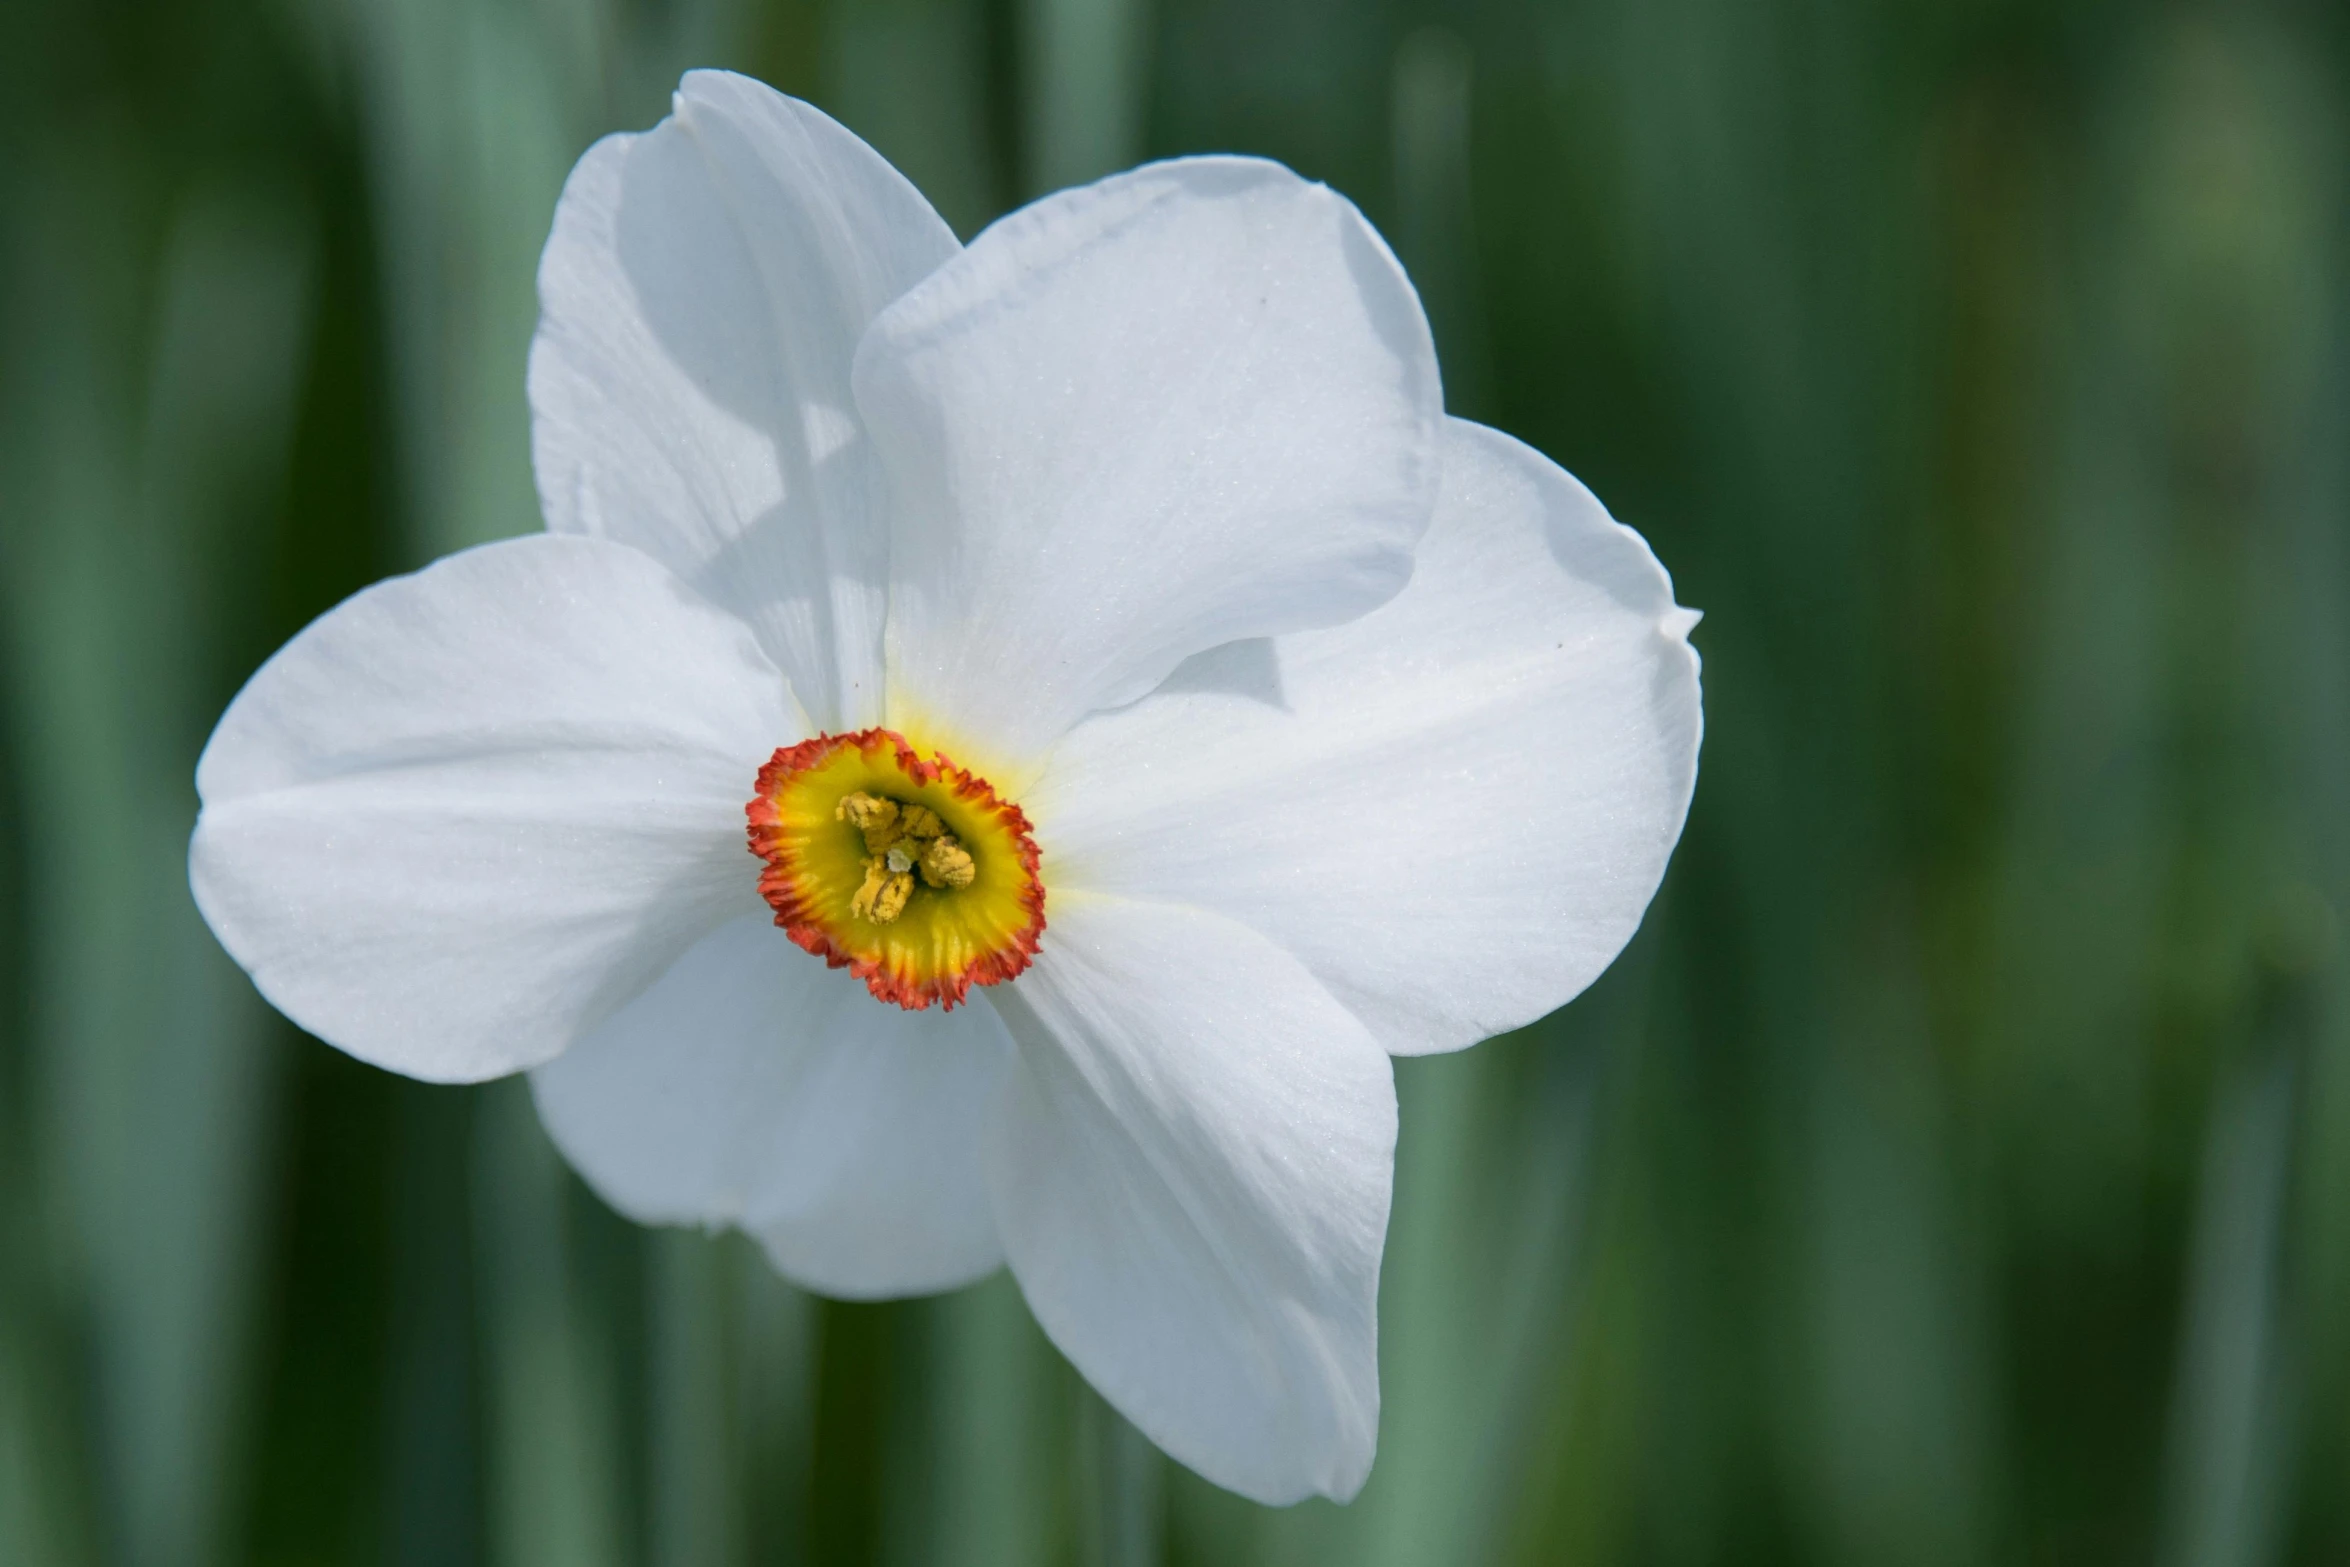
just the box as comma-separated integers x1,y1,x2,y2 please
1022,421,1701,1052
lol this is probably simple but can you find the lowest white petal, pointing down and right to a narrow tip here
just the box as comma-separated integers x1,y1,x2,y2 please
987,895,1396,1504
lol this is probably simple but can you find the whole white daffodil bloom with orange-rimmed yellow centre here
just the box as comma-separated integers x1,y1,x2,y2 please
190,73,1699,1501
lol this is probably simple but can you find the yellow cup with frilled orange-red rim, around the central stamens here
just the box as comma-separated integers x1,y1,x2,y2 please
745,728,1043,1013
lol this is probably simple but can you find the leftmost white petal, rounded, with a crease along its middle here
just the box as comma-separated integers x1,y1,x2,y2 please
188,536,806,1081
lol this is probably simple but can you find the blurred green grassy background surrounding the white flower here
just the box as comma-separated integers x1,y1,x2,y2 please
0,0,2350,1567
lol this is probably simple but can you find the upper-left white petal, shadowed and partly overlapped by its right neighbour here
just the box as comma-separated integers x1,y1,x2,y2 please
531,70,959,728
